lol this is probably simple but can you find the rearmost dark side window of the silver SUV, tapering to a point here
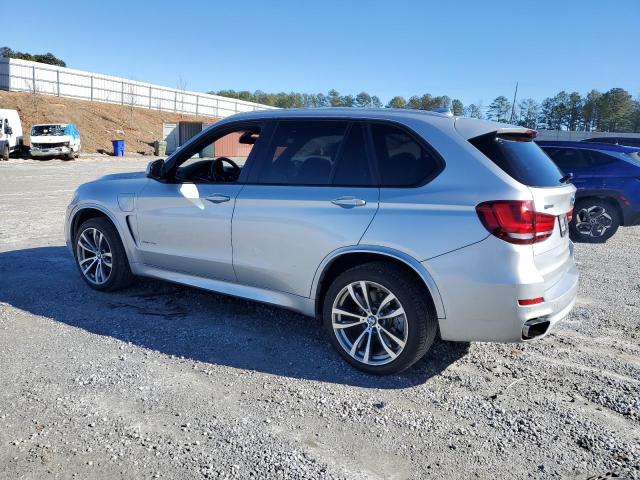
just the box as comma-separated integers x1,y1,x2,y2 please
371,124,440,187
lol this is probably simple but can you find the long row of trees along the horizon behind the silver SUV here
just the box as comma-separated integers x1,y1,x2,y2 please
214,88,640,133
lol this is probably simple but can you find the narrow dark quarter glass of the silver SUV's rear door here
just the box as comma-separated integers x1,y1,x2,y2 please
332,123,373,186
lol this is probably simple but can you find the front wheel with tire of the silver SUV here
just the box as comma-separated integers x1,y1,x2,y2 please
73,218,133,291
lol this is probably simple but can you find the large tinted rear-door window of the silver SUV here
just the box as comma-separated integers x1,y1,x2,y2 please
258,122,346,185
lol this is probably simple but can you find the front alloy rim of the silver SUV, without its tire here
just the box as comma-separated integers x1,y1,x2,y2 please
76,227,113,285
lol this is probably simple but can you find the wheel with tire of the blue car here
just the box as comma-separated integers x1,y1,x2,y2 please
569,198,622,243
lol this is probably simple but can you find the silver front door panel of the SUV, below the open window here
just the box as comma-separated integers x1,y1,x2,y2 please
136,181,242,281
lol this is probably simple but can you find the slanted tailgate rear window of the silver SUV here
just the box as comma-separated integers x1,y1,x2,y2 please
469,132,563,187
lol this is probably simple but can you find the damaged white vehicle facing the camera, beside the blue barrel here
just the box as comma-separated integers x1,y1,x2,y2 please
31,123,80,160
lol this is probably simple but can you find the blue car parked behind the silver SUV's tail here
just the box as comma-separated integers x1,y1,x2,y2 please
537,141,640,243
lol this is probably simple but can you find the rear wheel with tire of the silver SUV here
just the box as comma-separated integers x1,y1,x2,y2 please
322,262,438,375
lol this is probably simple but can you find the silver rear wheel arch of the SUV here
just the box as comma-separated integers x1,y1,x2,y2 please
311,245,445,318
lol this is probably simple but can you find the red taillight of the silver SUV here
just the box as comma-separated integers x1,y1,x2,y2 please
476,200,556,245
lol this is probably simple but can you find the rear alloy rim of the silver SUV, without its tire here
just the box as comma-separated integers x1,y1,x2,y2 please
331,280,409,365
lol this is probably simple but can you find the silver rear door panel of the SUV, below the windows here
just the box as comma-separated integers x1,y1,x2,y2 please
233,185,379,297
